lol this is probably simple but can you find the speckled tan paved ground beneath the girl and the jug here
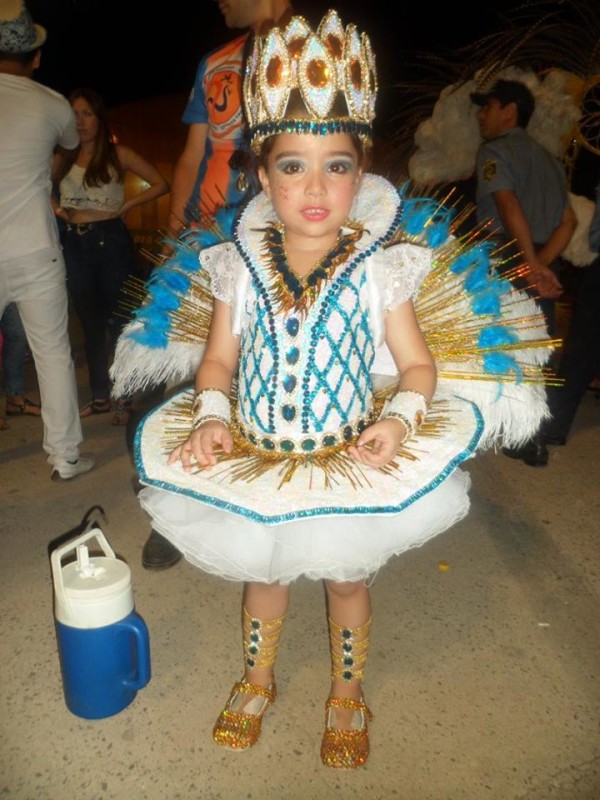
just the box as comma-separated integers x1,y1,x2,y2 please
0,350,600,800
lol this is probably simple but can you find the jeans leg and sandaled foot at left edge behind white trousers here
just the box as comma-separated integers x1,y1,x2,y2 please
0,303,42,430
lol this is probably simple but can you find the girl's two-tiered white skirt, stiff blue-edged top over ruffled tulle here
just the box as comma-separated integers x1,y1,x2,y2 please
135,397,483,584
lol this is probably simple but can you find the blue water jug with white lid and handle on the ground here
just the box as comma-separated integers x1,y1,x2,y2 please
50,528,150,719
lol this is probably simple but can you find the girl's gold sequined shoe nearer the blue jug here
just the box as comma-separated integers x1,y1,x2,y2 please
213,680,277,750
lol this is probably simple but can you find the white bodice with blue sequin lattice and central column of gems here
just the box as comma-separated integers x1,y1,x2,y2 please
239,257,375,448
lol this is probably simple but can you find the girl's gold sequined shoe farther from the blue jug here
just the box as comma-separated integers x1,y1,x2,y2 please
321,697,373,769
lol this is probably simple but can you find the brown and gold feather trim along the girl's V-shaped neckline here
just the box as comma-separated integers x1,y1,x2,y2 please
263,223,364,314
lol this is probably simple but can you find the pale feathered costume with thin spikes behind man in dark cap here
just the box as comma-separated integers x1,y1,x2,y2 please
384,0,600,267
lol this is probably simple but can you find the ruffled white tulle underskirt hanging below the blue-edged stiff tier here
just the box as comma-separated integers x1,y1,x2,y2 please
138,470,470,584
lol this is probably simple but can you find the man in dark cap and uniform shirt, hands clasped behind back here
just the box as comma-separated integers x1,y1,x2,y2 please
471,80,577,466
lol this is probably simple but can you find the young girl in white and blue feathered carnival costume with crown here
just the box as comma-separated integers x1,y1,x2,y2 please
113,11,551,768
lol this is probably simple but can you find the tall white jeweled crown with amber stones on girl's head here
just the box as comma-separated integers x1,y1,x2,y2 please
244,10,377,152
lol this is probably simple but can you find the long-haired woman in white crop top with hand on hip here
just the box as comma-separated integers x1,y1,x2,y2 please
53,87,169,425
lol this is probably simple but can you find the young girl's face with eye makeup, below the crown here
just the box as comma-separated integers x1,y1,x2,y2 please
259,133,362,247
